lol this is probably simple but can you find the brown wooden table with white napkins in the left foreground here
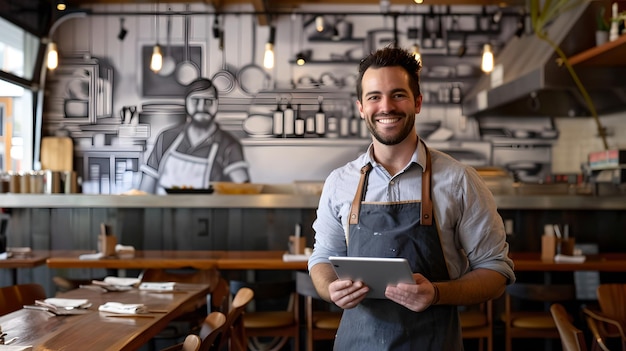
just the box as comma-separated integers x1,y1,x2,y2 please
0,284,212,351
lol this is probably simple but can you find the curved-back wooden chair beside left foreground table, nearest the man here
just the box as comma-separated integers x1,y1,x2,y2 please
217,287,254,351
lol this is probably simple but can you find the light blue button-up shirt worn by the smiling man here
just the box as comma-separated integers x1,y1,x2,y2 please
308,140,515,284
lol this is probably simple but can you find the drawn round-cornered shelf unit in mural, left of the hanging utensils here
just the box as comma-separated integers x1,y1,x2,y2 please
44,58,113,124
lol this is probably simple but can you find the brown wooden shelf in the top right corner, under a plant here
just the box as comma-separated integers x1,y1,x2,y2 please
569,34,626,66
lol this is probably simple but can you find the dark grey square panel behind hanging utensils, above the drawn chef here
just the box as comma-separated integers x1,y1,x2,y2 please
141,45,203,99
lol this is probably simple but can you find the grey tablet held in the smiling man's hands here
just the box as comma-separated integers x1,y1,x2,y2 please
328,256,415,299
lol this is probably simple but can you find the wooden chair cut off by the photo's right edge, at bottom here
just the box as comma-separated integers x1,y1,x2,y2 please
583,283,626,351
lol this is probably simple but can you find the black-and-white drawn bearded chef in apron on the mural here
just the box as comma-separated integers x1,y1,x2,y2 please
139,78,250,194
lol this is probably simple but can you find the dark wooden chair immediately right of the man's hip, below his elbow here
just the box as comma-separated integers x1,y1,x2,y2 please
459,300,493,351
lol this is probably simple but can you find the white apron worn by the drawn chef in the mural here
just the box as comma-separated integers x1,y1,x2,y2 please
157,132,219,194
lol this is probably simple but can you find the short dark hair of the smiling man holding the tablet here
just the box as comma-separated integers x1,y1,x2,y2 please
356,47,422,102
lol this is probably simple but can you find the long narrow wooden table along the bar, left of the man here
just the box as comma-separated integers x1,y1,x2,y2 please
46,250,307,270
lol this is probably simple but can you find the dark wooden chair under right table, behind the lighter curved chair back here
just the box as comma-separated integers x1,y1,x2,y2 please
503,283,576,351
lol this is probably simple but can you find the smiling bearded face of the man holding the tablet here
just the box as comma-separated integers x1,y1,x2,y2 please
357,67,422,145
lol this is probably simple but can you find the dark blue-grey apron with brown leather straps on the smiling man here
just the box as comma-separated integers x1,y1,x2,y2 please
334,144,463,351
